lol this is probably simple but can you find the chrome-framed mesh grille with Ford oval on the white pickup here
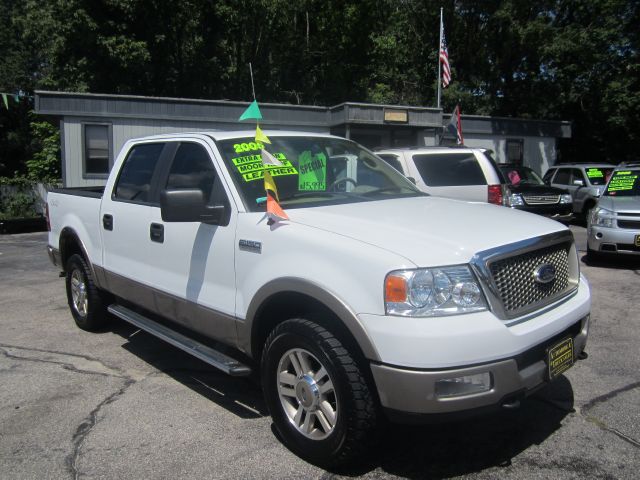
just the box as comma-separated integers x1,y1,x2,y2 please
471,230,580,322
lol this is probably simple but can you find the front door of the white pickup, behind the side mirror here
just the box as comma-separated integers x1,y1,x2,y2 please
147,140,236,344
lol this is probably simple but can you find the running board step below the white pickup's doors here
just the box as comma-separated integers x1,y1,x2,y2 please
108,304,251,377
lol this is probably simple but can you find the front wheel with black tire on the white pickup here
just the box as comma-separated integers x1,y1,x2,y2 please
261,319,377,468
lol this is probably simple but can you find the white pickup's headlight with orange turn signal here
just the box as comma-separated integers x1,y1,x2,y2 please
385,265,487,317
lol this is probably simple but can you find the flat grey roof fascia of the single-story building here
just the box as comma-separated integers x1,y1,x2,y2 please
35,90,571,138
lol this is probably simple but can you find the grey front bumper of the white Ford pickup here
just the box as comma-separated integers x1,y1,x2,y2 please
371,315,589,422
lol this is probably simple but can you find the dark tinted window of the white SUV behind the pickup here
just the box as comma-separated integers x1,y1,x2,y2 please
413,153,487,187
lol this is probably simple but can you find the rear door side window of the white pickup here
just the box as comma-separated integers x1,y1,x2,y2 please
113,143,164,203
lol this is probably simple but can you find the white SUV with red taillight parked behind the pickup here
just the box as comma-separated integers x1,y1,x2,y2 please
376,147,506,205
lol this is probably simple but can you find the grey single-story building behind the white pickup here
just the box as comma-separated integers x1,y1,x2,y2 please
35,91,571,187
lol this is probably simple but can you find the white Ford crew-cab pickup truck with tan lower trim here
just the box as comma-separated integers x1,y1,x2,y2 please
48,131,590,466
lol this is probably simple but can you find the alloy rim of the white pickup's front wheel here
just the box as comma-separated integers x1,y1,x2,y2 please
277,348,339,440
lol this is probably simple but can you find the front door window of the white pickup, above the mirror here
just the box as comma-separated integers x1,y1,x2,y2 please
166,143,216,200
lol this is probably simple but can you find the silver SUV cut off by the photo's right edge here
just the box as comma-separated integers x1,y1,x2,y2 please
587,163,640,258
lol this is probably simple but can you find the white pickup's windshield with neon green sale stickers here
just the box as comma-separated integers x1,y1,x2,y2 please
216,135,425,212
